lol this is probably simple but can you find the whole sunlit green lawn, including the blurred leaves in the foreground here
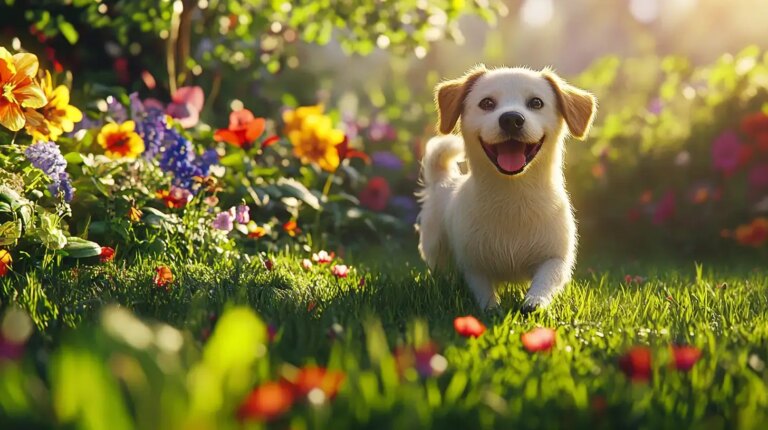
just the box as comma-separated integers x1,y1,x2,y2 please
0,252,768,428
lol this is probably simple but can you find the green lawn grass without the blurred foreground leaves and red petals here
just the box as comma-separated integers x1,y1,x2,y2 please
0,254,768,429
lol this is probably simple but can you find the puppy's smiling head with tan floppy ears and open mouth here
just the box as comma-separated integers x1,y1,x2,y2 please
437,67,595,176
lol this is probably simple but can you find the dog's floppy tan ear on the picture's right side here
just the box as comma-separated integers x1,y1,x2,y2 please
541,70,597,140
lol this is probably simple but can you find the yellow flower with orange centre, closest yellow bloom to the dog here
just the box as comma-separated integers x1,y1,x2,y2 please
283,105,344,172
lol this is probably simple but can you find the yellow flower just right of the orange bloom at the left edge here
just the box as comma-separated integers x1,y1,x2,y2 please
27,71,83,141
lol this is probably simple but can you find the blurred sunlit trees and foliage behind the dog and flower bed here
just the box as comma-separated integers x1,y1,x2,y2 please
0,0,768,259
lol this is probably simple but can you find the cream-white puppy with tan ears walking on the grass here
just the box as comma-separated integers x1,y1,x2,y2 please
417,65,597,313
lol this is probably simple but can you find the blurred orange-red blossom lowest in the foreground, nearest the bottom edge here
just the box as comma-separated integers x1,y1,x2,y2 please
237,382,294,421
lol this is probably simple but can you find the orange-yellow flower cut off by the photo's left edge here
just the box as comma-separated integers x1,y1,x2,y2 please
0,47,48,131
